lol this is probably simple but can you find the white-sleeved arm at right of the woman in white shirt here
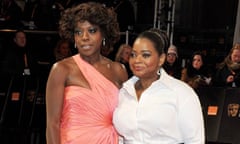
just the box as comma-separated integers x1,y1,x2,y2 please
179,89,205,144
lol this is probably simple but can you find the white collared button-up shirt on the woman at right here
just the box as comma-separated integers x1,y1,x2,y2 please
113,69,205,144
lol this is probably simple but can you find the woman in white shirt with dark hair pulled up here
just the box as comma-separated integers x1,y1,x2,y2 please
113,29,205,144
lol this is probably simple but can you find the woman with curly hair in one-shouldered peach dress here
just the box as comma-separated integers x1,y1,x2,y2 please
46,2,127,144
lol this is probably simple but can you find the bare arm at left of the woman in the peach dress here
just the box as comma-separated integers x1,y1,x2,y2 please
46,63,67,144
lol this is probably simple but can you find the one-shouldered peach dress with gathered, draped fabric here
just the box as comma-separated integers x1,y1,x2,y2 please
61,55,119,144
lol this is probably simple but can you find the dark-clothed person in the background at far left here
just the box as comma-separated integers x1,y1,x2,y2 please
4,29,37,76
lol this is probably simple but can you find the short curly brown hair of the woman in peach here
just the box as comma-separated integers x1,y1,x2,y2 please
59,2,120,51
